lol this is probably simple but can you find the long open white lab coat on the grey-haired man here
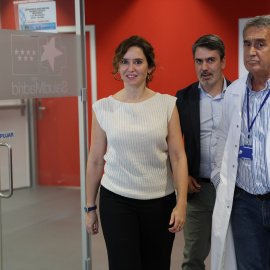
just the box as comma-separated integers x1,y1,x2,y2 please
211,76,247,270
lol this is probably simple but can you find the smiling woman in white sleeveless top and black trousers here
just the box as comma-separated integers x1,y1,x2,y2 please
85,36,187,270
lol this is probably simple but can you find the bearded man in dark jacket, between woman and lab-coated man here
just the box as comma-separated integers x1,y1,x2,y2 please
176,35,231,270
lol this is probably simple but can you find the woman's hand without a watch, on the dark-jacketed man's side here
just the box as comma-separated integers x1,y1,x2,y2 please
169,205,186,233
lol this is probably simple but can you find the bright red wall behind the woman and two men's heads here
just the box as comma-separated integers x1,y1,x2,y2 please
0,0,270,186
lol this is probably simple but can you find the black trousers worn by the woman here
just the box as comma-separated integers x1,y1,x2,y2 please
100,187,176,270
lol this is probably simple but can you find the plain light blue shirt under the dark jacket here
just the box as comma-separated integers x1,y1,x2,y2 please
198,78,227,178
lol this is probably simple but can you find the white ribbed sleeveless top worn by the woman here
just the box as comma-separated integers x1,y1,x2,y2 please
93,93,176,200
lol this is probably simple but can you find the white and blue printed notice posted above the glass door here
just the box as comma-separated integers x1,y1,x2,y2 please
13,0,57,33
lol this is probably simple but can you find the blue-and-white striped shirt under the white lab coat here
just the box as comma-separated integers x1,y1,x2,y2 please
236,74,270,194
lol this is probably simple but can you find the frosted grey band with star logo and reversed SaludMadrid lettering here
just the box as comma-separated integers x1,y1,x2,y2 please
0,30,82,99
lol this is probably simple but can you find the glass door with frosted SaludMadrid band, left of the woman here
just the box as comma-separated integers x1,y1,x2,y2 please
0,27,85,270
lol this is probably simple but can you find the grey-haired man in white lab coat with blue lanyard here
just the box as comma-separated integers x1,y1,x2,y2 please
211,15,270,270
